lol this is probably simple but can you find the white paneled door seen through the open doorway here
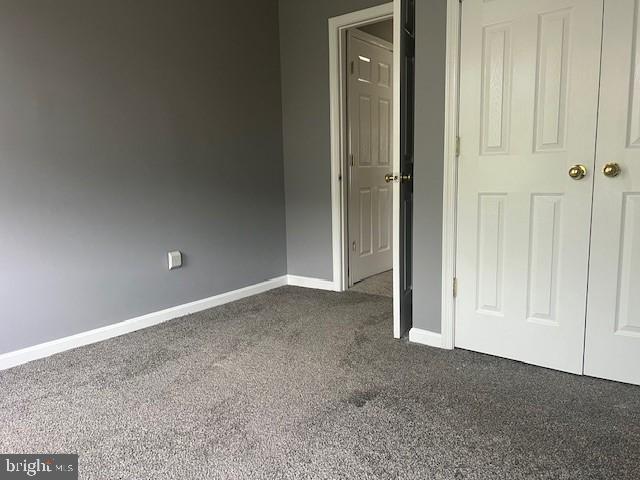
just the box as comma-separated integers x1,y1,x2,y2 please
347,30,393,285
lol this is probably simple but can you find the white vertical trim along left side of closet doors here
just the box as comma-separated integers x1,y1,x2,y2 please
440,0,462,349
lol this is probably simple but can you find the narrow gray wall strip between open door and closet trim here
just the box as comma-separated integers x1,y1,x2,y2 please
413,0,447,332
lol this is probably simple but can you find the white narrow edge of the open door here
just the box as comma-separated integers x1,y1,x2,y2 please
392,0,403,338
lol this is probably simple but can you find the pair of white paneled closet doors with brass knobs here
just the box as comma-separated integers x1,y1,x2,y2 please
455,0,640,384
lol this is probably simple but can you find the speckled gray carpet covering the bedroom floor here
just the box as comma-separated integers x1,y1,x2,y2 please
0,287,640,480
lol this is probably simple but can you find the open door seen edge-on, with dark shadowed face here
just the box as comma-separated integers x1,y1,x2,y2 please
393,0,415,338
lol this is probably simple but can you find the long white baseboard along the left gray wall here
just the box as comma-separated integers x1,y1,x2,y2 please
0,275,288,370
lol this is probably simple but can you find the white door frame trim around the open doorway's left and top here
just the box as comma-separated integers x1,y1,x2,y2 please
329,0,399,292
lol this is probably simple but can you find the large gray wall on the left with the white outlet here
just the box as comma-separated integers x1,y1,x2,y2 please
0,0,284,353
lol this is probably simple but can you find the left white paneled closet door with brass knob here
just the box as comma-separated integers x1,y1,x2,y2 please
455,0,604,373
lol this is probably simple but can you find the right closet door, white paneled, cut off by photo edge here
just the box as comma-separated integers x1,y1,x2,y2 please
585,0,640,384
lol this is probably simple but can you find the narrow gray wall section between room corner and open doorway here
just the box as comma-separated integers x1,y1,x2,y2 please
280,0,387,280
